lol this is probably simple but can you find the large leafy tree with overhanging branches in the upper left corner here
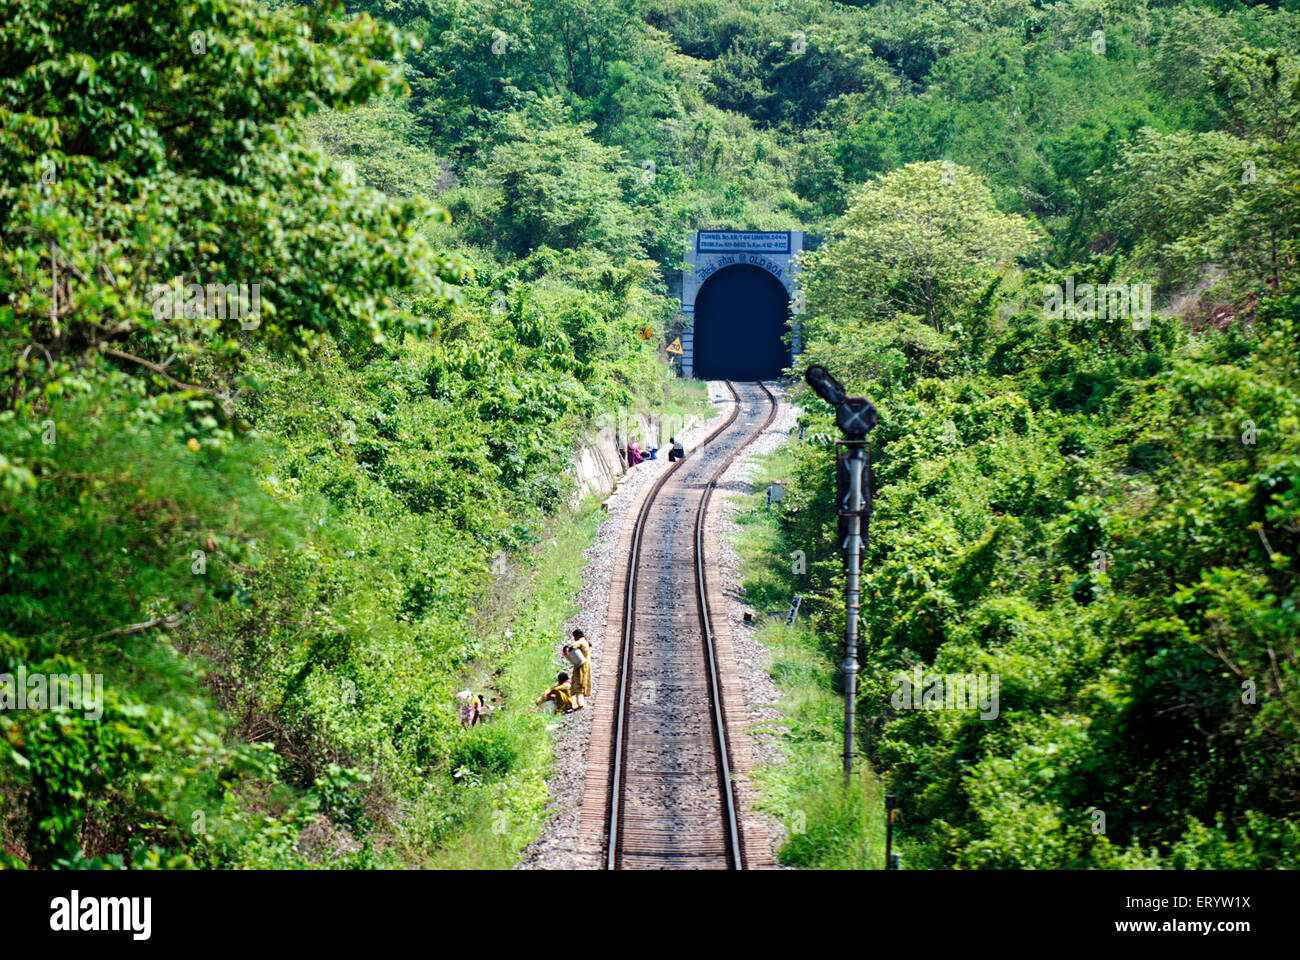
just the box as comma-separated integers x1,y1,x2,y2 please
0,0,462,402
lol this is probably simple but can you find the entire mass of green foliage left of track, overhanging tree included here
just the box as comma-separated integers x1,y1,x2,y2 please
0,0,688,866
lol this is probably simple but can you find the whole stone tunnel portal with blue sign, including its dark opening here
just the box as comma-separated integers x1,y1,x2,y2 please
681,230,803,380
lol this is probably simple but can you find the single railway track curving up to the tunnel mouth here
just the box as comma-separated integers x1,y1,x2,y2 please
605,381,776,869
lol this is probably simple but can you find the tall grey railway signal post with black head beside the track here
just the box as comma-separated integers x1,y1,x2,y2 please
803,364,876,780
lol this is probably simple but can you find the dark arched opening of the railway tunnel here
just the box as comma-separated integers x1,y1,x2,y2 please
694,263,790,380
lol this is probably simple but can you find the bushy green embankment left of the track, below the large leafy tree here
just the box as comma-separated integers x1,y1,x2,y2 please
4,330,694,866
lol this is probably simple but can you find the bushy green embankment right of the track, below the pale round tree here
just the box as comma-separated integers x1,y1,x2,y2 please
784,222,1300,869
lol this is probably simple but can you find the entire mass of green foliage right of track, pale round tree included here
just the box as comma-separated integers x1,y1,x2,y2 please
783,17,1300,869
